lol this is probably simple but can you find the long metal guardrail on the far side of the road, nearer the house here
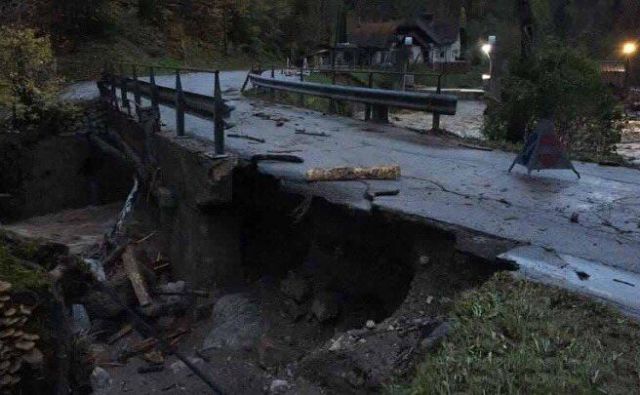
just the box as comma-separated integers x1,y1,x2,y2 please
242,70,458,130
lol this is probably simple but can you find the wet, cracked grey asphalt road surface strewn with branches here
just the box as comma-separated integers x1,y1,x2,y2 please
67,72,640,300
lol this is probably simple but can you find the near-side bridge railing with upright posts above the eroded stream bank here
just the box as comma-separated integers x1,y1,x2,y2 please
98,63,226,155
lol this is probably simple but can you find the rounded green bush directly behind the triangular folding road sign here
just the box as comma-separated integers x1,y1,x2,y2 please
484,43,620,155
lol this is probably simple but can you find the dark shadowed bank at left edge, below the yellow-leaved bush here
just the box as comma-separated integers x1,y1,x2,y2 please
0,133,132,222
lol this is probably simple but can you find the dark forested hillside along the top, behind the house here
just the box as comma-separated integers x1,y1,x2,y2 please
0,0,640,63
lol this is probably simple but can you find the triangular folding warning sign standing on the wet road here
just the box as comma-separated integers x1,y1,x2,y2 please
509,119,580,178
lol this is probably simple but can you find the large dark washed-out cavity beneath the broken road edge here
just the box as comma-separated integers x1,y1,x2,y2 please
225,168,496,341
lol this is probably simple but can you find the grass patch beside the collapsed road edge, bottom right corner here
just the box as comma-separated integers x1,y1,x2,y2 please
400,274,640,394
